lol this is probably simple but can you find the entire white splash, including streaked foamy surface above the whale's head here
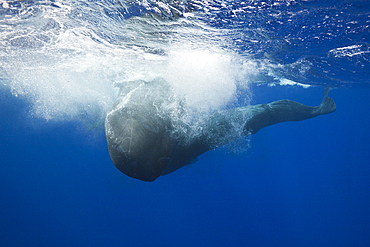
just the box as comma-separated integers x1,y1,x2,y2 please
0,1,266,134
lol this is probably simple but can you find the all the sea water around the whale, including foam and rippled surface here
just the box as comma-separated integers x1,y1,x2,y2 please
0,0,370,246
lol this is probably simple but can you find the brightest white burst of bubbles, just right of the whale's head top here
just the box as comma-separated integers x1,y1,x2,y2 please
164,50,236,111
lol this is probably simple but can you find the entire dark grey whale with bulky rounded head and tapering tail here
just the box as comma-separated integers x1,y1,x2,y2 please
105,79,336,181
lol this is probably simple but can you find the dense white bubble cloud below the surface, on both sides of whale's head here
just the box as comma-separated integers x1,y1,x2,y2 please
6,44,256,121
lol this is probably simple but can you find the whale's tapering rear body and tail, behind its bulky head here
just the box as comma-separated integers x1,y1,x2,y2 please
162,88,336,175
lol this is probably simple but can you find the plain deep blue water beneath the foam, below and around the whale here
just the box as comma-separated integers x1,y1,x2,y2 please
0,86,370,246
